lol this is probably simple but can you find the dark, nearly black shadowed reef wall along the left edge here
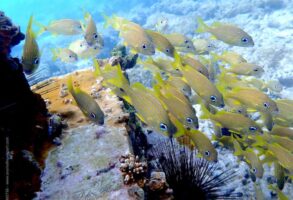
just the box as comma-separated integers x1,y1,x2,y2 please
0,11,60,200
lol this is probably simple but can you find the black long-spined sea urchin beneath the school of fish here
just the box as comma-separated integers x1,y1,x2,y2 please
151,140,242,200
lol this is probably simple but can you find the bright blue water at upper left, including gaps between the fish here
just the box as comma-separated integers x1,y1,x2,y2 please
0,0,156,77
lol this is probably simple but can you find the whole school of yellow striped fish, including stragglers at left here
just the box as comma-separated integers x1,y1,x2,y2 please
22,13,293,199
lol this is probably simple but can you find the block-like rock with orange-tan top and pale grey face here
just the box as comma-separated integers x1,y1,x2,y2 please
33,69,135,200
